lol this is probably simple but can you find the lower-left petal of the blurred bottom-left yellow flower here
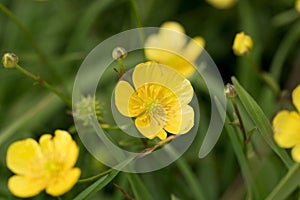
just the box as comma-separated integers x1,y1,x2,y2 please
8,175,45,198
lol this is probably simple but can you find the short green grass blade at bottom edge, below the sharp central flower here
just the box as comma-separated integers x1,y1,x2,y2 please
128,173,153,200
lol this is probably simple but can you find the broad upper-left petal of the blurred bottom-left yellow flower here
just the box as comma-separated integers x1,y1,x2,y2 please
6,139,44,175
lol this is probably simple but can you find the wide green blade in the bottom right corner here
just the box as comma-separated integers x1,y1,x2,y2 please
266,164,300,200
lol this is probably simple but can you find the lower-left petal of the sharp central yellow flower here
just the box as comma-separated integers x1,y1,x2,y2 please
135,114,163,139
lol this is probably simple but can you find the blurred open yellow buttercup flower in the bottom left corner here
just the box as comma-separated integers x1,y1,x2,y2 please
6,130,80,198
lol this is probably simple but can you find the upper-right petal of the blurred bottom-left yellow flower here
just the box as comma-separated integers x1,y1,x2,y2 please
53,130,79,169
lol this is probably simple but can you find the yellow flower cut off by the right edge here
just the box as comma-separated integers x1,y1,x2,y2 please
273,85,300,163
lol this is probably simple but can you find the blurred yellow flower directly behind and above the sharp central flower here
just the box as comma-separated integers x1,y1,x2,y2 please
145,22,205,77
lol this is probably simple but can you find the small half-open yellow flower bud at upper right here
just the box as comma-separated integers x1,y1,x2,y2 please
232,32,253,56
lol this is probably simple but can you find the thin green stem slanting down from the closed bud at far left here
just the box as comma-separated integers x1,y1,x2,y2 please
16,64,72,108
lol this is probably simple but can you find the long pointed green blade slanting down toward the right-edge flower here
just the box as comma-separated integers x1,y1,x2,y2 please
232,77,293,168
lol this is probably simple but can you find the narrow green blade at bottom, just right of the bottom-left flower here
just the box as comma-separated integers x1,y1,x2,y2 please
74,170,119,200
